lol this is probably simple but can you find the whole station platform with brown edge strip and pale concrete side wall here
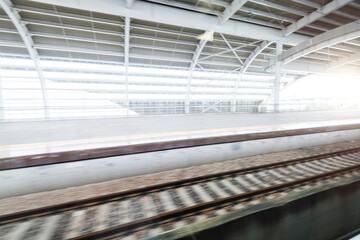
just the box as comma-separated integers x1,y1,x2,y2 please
0,111,360,198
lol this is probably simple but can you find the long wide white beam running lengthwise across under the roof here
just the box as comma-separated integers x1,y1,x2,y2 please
28,0,308,45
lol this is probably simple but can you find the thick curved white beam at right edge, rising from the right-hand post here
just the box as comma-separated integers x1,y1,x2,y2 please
279,20,360,64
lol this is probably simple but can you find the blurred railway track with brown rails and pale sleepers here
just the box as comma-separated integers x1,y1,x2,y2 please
0,148,360,239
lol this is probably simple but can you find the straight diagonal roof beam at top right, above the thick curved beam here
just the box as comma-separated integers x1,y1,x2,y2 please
284,0,352,36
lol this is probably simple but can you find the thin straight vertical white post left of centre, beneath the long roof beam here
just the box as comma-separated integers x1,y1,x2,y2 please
124,17,130,116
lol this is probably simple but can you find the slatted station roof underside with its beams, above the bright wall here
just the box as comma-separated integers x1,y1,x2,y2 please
0,0,360,73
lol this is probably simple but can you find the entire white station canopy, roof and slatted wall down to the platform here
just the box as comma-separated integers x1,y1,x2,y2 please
0,0,360,119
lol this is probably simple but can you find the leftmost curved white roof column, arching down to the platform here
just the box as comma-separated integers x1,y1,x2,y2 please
0,0,49,118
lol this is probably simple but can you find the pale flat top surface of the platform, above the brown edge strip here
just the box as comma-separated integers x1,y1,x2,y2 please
0,111,360,159
